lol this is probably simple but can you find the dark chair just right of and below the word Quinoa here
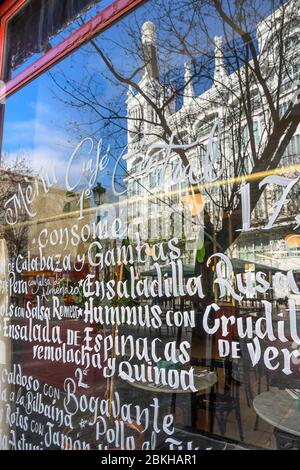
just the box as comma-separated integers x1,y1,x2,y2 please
191,359,244,441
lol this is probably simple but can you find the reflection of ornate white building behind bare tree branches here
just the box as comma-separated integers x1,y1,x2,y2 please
124,2,300,276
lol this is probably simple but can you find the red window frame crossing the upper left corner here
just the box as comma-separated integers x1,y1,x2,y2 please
0,0,147,101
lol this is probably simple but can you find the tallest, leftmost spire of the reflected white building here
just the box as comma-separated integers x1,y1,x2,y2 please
142,21,158,79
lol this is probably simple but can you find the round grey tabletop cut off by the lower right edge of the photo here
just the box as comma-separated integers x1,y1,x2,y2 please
253,387,300,436
